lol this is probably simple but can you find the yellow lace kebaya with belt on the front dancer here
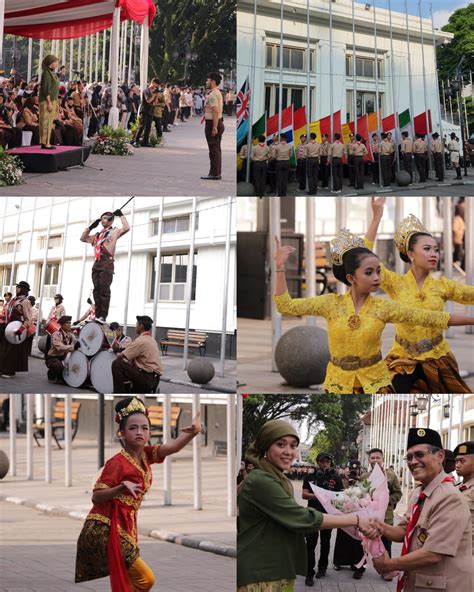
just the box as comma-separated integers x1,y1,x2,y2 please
273,291,450,394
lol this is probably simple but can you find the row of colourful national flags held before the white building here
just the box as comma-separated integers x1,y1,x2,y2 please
237,78,432,165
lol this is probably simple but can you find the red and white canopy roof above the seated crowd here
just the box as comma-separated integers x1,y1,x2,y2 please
4,0,156,39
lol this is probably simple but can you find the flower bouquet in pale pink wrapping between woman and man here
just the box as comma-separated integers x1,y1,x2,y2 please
311,465,393,575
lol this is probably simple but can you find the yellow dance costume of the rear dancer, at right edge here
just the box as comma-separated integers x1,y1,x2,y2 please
365,238,474,393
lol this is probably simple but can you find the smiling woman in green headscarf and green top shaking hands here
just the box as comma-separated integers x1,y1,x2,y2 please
237,419,369,592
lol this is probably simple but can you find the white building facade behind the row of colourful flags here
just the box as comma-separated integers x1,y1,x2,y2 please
237,0,452,131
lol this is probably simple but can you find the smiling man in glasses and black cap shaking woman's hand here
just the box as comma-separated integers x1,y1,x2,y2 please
373,428,472,592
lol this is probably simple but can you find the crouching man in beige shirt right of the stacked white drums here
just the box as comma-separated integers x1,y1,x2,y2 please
112,315,161,393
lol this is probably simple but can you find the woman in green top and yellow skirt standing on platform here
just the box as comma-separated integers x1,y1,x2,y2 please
39,55,59,150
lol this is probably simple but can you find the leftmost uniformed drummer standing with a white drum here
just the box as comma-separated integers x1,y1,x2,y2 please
0,282,32,378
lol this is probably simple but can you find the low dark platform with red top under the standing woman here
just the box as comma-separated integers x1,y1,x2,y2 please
8,146,91,173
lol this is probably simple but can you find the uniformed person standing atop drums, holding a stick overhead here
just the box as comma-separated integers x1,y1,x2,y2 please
81,210,130,322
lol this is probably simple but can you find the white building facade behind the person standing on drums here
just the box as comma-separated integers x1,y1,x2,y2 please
0,197,236,357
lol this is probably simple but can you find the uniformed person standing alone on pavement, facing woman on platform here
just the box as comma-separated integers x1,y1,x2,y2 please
201,72,224,181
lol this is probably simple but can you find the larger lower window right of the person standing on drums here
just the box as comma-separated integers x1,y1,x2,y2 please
150,253,197,302
